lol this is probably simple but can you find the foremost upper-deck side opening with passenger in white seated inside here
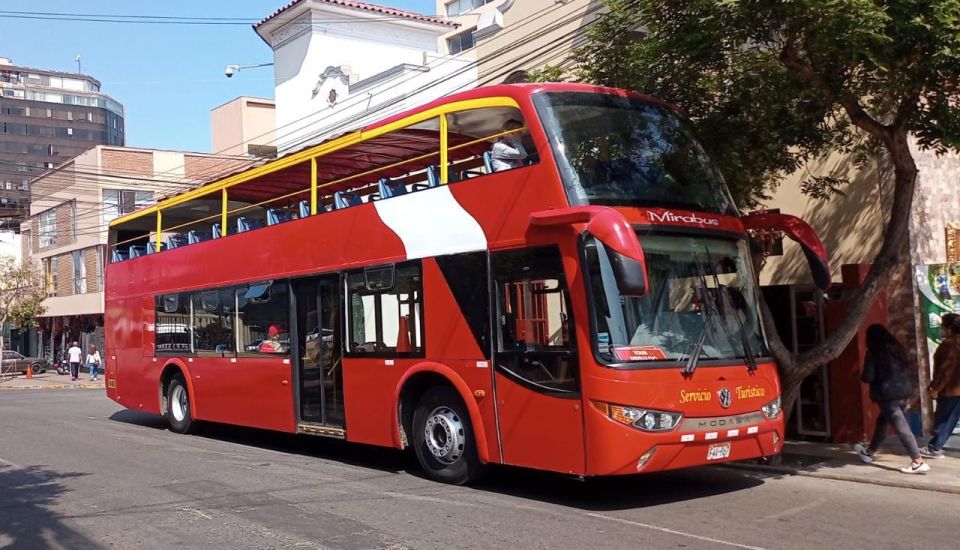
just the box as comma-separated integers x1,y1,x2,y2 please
447,107,539,181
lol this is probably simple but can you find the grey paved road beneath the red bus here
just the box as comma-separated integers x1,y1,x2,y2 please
0,390,960,550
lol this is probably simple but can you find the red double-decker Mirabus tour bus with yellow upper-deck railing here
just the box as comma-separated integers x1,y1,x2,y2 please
105,84,825,483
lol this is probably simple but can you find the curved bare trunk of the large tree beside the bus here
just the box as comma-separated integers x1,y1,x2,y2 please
762,128,918,416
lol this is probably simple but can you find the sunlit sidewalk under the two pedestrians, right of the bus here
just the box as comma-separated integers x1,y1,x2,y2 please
723,436,960,494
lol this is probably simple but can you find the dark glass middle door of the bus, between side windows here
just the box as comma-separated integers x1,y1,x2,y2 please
293,275,345,428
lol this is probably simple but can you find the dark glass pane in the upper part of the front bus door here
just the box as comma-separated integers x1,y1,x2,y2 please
491,246,579,393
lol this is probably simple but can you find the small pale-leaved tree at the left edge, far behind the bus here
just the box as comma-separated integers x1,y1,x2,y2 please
0,256,46,378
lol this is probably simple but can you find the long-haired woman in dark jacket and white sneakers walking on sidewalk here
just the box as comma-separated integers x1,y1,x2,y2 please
854,325,930,474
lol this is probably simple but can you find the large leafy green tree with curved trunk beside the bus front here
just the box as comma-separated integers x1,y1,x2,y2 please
575,0,960,411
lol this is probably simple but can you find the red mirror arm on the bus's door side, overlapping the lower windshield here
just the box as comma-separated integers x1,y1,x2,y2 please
530,206,648,296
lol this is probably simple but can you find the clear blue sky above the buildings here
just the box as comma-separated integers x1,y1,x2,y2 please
0,0,436,152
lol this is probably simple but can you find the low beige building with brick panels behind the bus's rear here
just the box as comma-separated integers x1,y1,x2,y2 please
21,145,254,356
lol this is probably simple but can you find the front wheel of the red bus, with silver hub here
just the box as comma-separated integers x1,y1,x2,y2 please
413,386,484,485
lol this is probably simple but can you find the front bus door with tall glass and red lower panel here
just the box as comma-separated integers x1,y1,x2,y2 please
491,246,585,473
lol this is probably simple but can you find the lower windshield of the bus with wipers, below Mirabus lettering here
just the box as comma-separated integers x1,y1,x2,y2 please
584,235,768,364
